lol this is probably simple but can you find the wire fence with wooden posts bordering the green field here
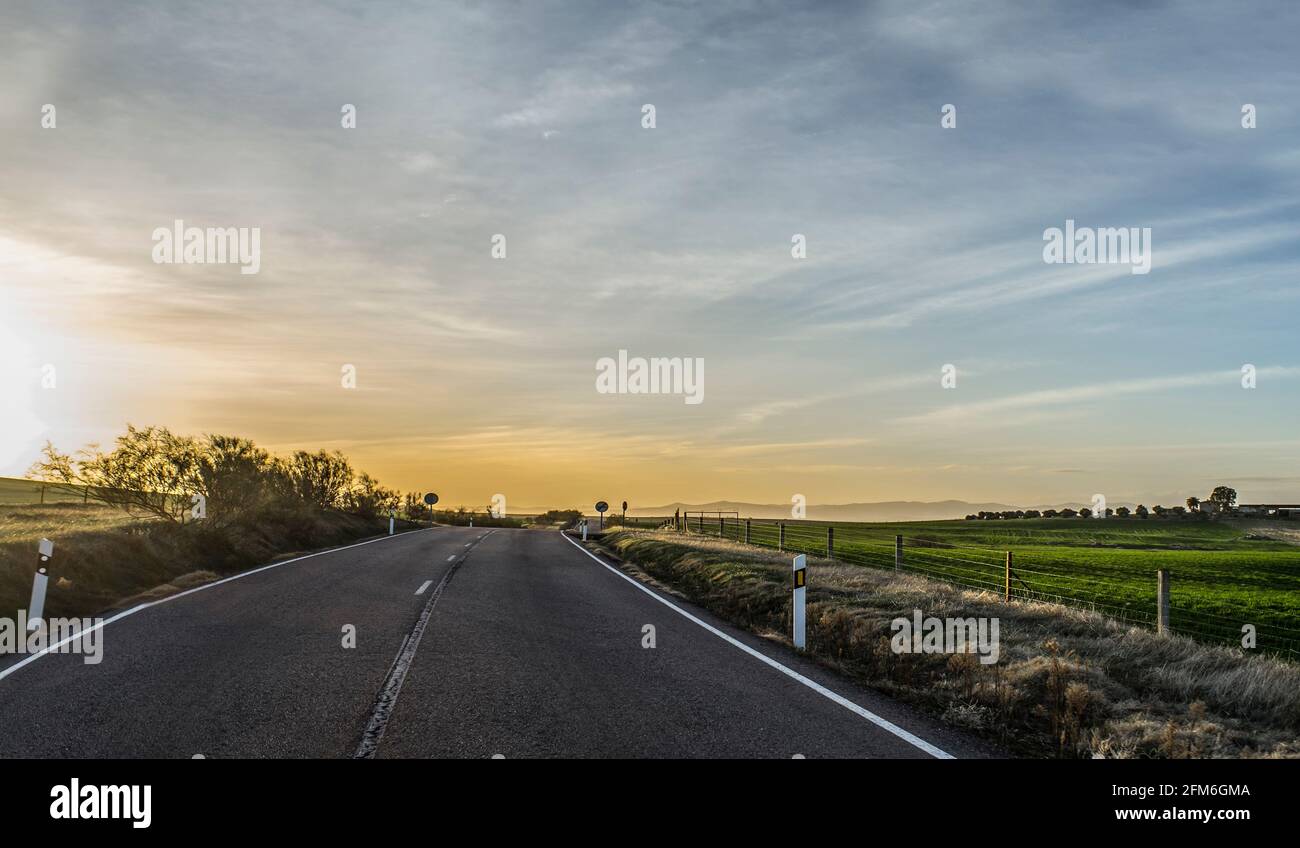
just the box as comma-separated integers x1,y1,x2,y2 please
612,514,1300,659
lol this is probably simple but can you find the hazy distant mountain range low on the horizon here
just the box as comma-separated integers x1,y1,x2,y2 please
610,501,1136,522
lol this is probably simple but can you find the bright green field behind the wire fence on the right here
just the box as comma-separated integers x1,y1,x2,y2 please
629,518,1300,658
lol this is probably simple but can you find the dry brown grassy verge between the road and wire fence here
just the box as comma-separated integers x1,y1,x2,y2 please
602,531,1300,758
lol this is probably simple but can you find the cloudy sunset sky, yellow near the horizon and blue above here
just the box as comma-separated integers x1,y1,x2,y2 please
0,0,1300,507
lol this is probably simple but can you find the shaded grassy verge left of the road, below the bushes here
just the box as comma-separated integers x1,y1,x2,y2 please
0,503,406,616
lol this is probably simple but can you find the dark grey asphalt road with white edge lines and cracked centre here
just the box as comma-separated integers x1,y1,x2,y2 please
0,527,991,758
